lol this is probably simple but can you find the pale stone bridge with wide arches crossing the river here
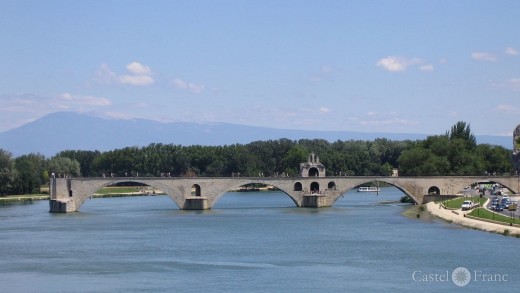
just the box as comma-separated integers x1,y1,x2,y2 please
49,176,520,213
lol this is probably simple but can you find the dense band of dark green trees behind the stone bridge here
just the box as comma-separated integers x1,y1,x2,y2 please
0,122,513,194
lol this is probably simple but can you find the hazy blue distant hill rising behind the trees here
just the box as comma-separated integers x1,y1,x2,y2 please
0,112,512,157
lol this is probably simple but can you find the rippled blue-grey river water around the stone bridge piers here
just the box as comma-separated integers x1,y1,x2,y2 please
0,188,520,292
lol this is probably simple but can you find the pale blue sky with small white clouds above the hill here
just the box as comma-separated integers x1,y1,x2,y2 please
0,0,520,135
